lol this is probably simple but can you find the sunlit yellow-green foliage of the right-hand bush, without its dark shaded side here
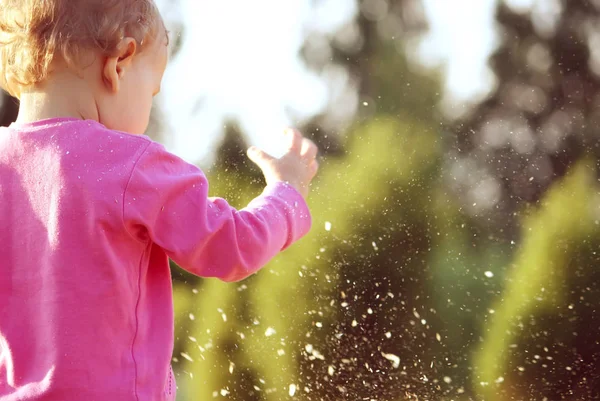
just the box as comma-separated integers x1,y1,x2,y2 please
475,160,599,400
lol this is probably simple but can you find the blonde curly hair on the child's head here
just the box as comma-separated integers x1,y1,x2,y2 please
0,0,162,97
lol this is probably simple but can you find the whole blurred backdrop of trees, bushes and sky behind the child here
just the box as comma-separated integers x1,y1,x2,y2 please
0,0,600,401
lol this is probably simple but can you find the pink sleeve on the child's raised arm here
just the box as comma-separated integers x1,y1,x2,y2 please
123,143,311,281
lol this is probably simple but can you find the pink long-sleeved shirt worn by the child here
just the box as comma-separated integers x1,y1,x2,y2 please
0,119,311,401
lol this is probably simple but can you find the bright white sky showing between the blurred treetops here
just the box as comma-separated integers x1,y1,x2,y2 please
158,0,502,164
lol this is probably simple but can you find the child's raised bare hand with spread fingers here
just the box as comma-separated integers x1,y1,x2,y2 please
248,128,319,198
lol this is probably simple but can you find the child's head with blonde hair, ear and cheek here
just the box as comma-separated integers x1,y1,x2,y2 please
0,0,168,133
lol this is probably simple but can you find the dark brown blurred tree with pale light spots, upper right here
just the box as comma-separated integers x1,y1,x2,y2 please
448,0,600,228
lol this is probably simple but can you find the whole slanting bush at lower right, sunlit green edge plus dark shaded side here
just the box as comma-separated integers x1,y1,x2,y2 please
475,160,600,400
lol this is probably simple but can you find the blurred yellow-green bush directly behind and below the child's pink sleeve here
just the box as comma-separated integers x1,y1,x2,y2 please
175,116,440,400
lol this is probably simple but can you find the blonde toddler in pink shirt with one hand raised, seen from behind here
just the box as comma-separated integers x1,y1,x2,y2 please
0,0,318,401
